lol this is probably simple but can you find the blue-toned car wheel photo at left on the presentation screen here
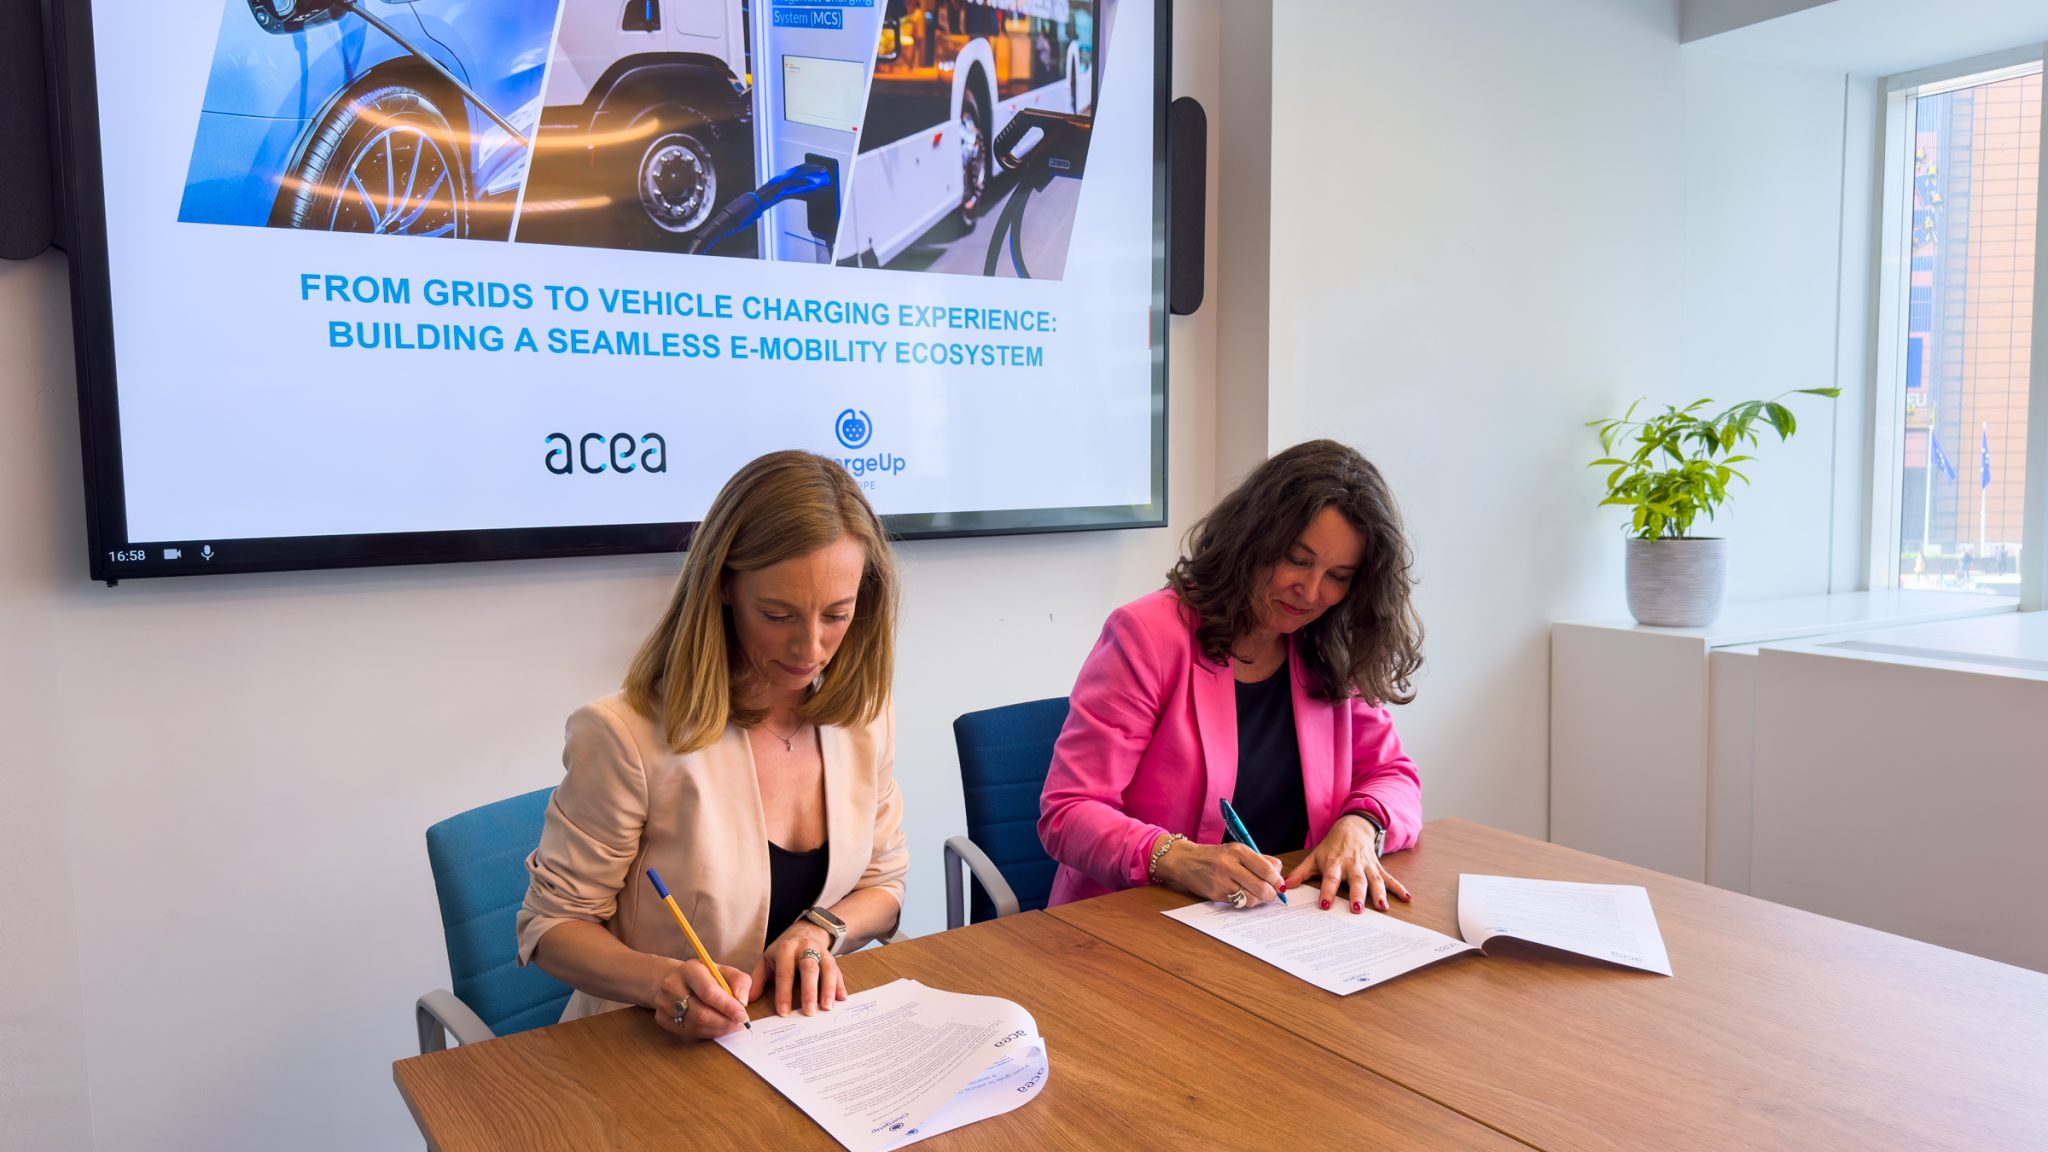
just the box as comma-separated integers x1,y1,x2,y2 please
178,0,557,240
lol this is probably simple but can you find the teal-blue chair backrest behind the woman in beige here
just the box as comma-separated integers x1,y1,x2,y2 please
426,787,569,1035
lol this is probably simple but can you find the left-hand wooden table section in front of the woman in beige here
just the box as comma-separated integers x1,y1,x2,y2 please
393,912,1520,1152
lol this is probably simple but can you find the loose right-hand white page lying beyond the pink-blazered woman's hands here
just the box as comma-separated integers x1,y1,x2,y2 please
1458,873,1671,976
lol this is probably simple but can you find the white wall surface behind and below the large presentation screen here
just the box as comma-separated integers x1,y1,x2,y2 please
0,2,1223,1152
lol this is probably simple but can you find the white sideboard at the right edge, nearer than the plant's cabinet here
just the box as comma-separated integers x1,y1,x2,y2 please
1749,613,2048,972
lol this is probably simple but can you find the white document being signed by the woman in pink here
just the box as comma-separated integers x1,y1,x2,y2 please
1167,890,1479,996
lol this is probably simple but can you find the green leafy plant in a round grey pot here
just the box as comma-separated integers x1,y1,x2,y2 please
1587,387,1841,627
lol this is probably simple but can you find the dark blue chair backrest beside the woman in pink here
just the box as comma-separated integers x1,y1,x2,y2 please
952,697,1067,922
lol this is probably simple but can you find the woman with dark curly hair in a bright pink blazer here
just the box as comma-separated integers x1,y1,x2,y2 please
1038,441,1421,912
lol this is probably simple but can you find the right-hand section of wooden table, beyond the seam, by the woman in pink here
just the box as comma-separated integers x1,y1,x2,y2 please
1051,820,2048,1152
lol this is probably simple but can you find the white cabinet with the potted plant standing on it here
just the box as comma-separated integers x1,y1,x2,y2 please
1550,592,2013,877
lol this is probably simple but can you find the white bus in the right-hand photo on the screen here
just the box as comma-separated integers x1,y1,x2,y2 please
836,0,1096,264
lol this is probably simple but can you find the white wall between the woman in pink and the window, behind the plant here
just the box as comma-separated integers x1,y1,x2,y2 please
1270,0,1868,834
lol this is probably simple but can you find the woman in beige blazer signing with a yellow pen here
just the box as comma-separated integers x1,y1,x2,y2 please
518,451,909,1039
